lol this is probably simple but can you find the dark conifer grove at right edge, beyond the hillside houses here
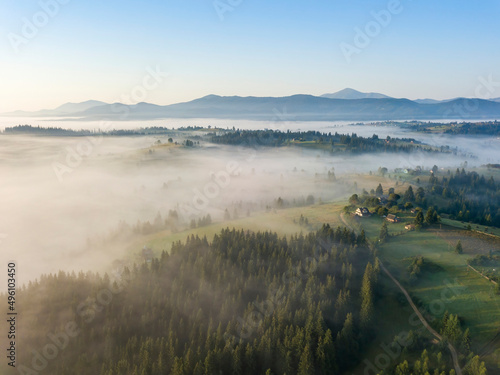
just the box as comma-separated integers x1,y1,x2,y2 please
426,168,500,227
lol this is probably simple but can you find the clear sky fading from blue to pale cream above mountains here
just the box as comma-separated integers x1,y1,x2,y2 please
0,0,500,112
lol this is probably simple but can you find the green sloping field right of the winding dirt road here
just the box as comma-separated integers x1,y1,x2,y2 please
370,226,500,349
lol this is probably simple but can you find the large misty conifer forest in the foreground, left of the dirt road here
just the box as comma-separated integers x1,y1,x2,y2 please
10,225,386,375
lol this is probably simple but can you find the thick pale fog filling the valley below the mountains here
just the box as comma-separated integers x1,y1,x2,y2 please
0,121,499,283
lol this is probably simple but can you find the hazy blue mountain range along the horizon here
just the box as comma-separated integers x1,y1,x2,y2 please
1,89,500,121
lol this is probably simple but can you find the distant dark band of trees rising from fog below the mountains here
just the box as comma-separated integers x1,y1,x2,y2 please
210,129,435,153
